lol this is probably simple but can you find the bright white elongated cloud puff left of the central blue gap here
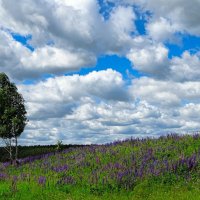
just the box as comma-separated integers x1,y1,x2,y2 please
21,46,96,74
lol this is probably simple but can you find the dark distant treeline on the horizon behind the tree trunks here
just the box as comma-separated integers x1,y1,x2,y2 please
0,144,85,162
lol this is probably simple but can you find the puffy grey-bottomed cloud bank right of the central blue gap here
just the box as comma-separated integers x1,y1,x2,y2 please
127,45,200,82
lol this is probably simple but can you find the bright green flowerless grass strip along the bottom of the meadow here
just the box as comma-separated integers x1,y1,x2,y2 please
0,181,200,200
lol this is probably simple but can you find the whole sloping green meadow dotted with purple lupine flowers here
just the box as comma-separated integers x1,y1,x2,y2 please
0,135,200,200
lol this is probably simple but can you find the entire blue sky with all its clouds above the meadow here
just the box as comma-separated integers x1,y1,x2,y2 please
0,0,200,145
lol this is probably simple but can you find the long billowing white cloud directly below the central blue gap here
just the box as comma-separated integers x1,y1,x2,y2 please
19,69,129,118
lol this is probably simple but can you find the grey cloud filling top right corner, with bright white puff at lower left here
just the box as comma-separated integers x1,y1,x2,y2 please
107,0,200,39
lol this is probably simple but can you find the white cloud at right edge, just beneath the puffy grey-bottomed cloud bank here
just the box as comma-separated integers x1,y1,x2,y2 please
129,77,200,109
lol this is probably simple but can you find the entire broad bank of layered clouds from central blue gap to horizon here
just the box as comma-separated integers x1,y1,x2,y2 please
18,69,200,144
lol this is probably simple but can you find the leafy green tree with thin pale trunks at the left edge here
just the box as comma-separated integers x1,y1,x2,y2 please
0,73,27,162
